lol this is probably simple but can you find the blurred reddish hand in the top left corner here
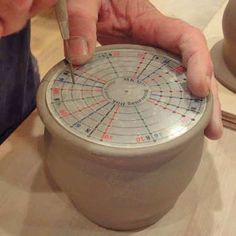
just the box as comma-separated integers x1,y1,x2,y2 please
0,0,56,37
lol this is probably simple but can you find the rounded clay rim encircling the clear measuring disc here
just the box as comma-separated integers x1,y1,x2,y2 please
37,44,213,159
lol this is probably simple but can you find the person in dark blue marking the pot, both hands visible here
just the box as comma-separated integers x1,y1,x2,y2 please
0,0,223,141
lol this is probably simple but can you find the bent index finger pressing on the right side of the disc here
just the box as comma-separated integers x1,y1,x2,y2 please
132,9,212,97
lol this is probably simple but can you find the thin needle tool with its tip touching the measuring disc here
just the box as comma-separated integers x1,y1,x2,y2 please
55,0,75,84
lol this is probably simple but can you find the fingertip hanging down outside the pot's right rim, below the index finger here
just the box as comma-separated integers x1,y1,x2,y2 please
205,76,223,139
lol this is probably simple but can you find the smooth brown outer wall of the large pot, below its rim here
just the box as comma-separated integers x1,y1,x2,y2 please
45,130,204,230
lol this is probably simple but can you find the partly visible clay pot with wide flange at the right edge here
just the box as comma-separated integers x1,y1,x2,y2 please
211,0,236,92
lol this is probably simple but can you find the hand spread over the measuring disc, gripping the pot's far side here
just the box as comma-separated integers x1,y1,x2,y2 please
68,0,223,139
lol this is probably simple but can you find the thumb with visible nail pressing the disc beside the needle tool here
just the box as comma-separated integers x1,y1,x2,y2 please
68,0,101,65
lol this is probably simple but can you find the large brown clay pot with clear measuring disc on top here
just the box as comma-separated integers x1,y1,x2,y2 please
37,45,212,230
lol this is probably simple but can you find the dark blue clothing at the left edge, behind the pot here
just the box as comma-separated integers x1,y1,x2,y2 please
0,24,39,144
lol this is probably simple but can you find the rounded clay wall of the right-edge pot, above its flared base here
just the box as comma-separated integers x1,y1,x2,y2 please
223,0,236,76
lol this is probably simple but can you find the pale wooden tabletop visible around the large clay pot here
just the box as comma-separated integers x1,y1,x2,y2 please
0,0,236,236
